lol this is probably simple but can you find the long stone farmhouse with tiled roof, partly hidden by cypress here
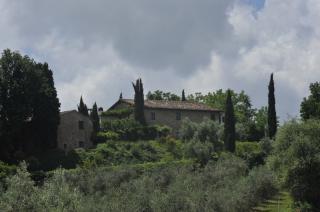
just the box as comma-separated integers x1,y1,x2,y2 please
106,98,224,135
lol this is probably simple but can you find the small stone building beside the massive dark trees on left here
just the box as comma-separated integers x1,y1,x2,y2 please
57,110,93,152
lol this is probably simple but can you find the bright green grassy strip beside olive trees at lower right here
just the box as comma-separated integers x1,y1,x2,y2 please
253,192,293,212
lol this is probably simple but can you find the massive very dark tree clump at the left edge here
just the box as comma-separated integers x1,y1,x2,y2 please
0,49,60,162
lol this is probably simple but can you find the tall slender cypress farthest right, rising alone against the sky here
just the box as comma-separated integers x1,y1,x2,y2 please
268,73,277,138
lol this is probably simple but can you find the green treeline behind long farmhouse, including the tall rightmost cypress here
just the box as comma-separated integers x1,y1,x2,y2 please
146,74,278,141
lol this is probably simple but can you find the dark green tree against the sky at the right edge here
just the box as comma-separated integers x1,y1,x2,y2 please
300,82,320,120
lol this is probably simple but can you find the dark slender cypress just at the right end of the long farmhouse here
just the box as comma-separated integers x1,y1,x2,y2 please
224,90,236,152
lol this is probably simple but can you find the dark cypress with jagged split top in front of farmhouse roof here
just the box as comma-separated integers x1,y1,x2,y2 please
132,79,146,125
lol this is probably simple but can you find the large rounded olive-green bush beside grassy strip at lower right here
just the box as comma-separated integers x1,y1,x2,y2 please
269,120,320,209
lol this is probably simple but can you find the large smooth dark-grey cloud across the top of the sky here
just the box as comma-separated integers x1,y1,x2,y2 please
5,0,233,74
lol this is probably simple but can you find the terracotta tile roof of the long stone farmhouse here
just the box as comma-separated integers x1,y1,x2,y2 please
119,99,221,111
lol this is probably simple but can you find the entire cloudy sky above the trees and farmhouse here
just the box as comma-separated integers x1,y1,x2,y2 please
0,0,320,120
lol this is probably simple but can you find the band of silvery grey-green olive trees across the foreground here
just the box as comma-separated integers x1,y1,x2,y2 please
0,154,276,212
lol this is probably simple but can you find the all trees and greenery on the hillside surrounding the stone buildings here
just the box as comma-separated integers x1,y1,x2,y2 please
0,50,320,212
